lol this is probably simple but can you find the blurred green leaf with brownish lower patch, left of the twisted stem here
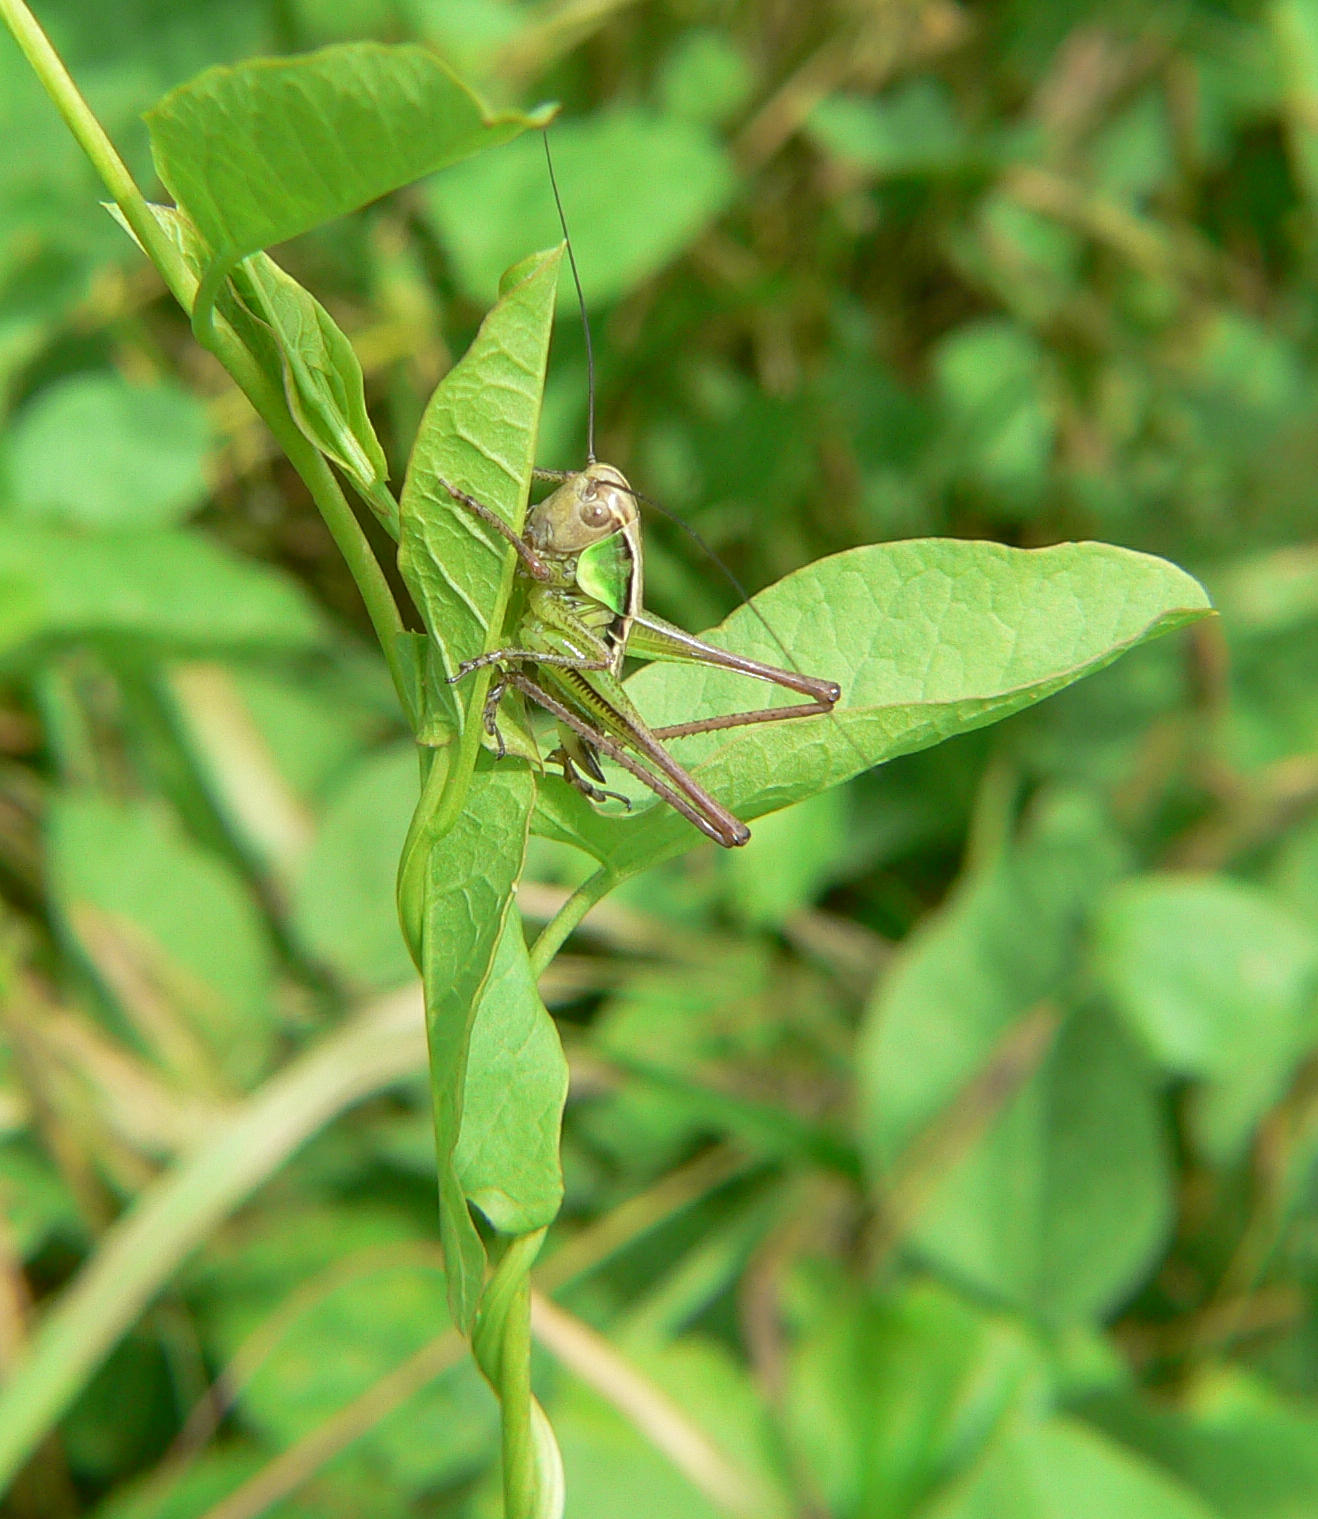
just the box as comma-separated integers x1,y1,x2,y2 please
49,791,278,1091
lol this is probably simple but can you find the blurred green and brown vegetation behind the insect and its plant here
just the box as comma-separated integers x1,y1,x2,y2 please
0,0,1318,1519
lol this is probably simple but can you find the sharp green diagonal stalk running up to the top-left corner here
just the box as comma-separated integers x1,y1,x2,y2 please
0,0,415,717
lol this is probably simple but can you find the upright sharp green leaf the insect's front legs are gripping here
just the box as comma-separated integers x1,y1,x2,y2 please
398,248,562,725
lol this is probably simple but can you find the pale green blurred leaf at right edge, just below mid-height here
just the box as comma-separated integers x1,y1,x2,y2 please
1095,875,1318,1159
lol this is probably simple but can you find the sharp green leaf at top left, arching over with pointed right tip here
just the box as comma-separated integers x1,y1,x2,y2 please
146,43,550,276
